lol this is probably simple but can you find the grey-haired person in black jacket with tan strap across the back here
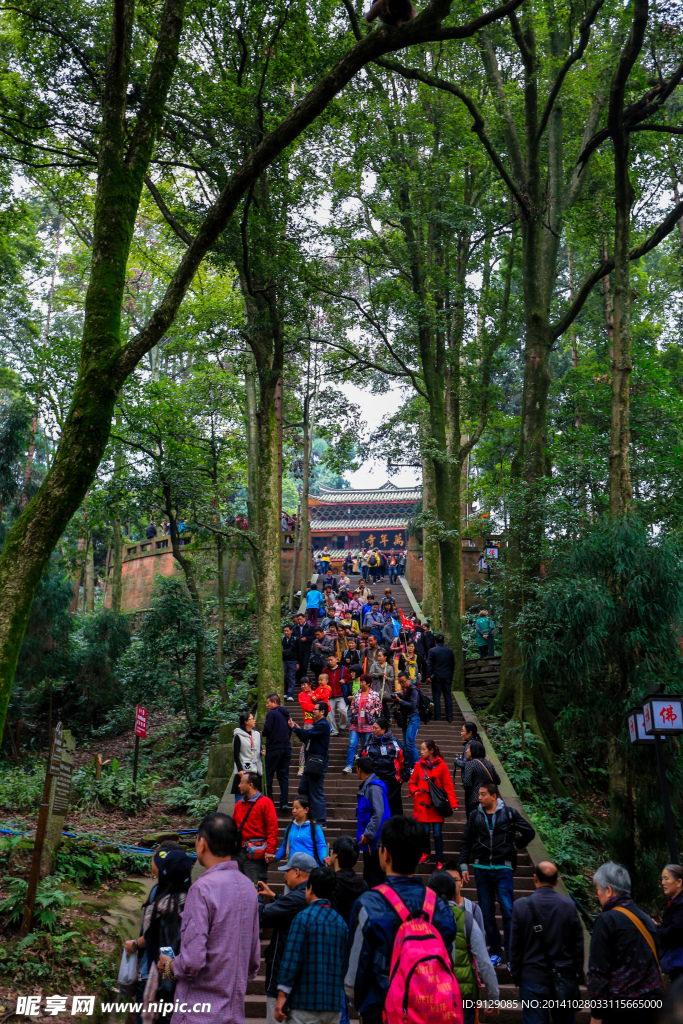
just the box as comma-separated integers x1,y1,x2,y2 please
588,861,663,1024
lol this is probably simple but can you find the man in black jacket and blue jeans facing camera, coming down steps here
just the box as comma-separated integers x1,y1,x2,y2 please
460,782,536,967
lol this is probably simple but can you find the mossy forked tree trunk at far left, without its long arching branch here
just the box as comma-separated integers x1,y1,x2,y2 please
0,0,183,737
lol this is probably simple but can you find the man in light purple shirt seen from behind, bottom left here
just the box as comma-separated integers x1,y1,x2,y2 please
159,813,261,1024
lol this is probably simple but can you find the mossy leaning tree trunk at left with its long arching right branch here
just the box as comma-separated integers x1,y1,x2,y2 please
0,0,521,741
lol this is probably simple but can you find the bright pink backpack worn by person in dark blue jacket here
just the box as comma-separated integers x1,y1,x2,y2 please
376,886,463,1024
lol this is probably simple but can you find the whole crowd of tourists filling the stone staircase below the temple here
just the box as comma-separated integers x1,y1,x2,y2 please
125,570,683,1024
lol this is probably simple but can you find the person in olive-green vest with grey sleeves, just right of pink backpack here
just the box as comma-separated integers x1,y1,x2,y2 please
427,869,500,1024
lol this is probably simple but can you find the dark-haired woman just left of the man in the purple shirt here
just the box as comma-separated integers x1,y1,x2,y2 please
142,848,193,1024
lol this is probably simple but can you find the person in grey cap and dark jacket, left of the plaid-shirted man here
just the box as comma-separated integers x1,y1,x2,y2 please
258,851,316,1024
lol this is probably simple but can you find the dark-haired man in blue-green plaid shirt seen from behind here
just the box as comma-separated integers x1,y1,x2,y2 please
274,867,348,1024
